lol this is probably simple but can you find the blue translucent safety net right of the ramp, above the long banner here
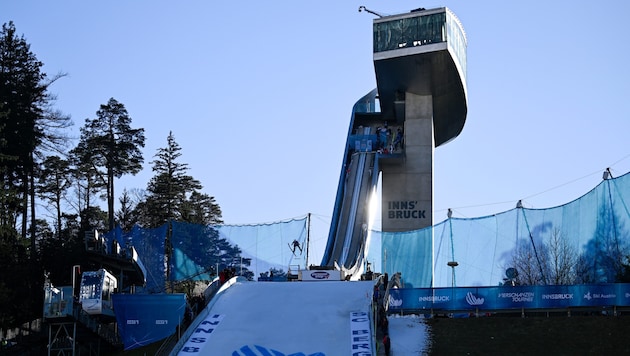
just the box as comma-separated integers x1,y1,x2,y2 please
368,173,630,288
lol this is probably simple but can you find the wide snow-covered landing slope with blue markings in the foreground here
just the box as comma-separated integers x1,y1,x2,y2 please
175,280,374,356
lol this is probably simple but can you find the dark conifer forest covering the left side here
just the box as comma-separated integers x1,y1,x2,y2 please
0,22,247,329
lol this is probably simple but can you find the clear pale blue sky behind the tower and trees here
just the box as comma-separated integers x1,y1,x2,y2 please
0,0,630,238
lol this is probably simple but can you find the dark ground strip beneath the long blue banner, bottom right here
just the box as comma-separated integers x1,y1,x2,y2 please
428,314,630,356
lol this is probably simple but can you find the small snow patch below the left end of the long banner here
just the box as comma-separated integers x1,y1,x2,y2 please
388,314,430,356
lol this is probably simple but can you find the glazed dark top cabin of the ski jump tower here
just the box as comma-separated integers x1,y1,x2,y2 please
373,7,468,147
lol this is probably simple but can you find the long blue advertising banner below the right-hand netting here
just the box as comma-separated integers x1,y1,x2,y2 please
389,283,630,311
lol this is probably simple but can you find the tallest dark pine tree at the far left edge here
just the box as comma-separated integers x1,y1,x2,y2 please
0,22,71,327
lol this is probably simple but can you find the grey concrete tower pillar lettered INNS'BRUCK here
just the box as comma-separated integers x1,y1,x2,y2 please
380,93,435,232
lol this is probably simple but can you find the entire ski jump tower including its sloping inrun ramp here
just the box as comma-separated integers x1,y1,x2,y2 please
322,7,468,283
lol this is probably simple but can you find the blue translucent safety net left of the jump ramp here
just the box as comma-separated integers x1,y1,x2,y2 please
105,215,307,293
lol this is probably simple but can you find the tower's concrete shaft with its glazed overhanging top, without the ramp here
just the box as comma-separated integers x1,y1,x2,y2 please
374,8,468,232
